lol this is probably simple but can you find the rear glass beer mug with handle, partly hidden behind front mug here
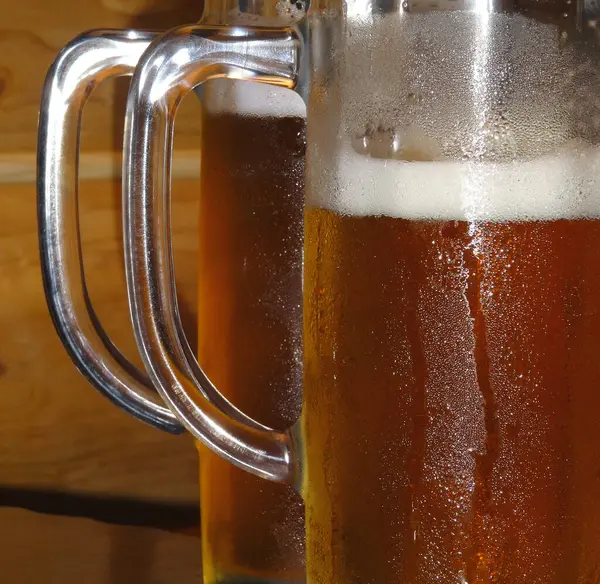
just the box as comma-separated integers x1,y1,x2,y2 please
40,1,305,584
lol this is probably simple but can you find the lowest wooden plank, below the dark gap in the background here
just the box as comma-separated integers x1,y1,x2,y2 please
0,509,202,584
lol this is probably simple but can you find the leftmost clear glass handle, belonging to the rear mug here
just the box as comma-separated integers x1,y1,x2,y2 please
37,30,184,434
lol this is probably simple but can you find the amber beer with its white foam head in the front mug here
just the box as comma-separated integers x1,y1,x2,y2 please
303,149,600,584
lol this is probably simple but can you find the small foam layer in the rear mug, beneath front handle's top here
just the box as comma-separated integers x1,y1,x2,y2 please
203,79,306,118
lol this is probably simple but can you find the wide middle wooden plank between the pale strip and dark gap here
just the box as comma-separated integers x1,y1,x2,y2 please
0,180,198,502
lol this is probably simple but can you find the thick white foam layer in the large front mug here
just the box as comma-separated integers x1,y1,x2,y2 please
308,146,600,221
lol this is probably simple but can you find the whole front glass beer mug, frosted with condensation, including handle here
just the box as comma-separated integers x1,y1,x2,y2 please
36,0,600,584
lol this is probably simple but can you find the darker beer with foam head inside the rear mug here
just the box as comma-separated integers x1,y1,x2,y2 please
198,82,305,584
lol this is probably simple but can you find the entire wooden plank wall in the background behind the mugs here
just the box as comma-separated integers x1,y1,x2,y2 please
0,0,210,584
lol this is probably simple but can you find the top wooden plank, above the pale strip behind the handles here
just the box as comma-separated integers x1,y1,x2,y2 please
0,0,203,154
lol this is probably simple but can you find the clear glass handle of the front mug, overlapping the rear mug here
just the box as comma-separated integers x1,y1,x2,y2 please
123,25,302,485
